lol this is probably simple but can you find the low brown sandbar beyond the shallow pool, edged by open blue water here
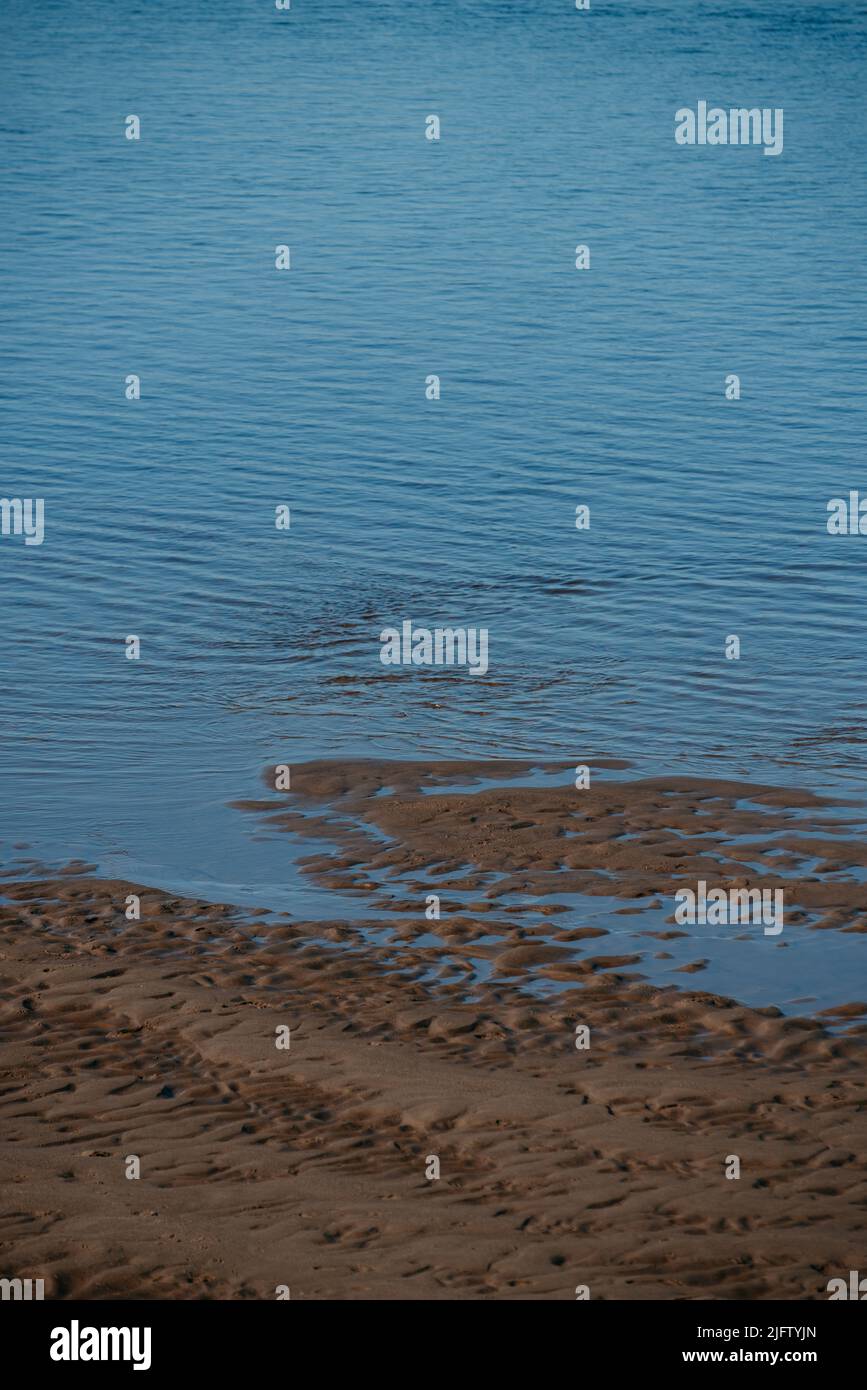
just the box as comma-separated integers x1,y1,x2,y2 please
235,762,867,931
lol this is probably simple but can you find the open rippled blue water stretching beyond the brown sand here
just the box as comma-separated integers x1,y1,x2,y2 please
0,0,867,911
